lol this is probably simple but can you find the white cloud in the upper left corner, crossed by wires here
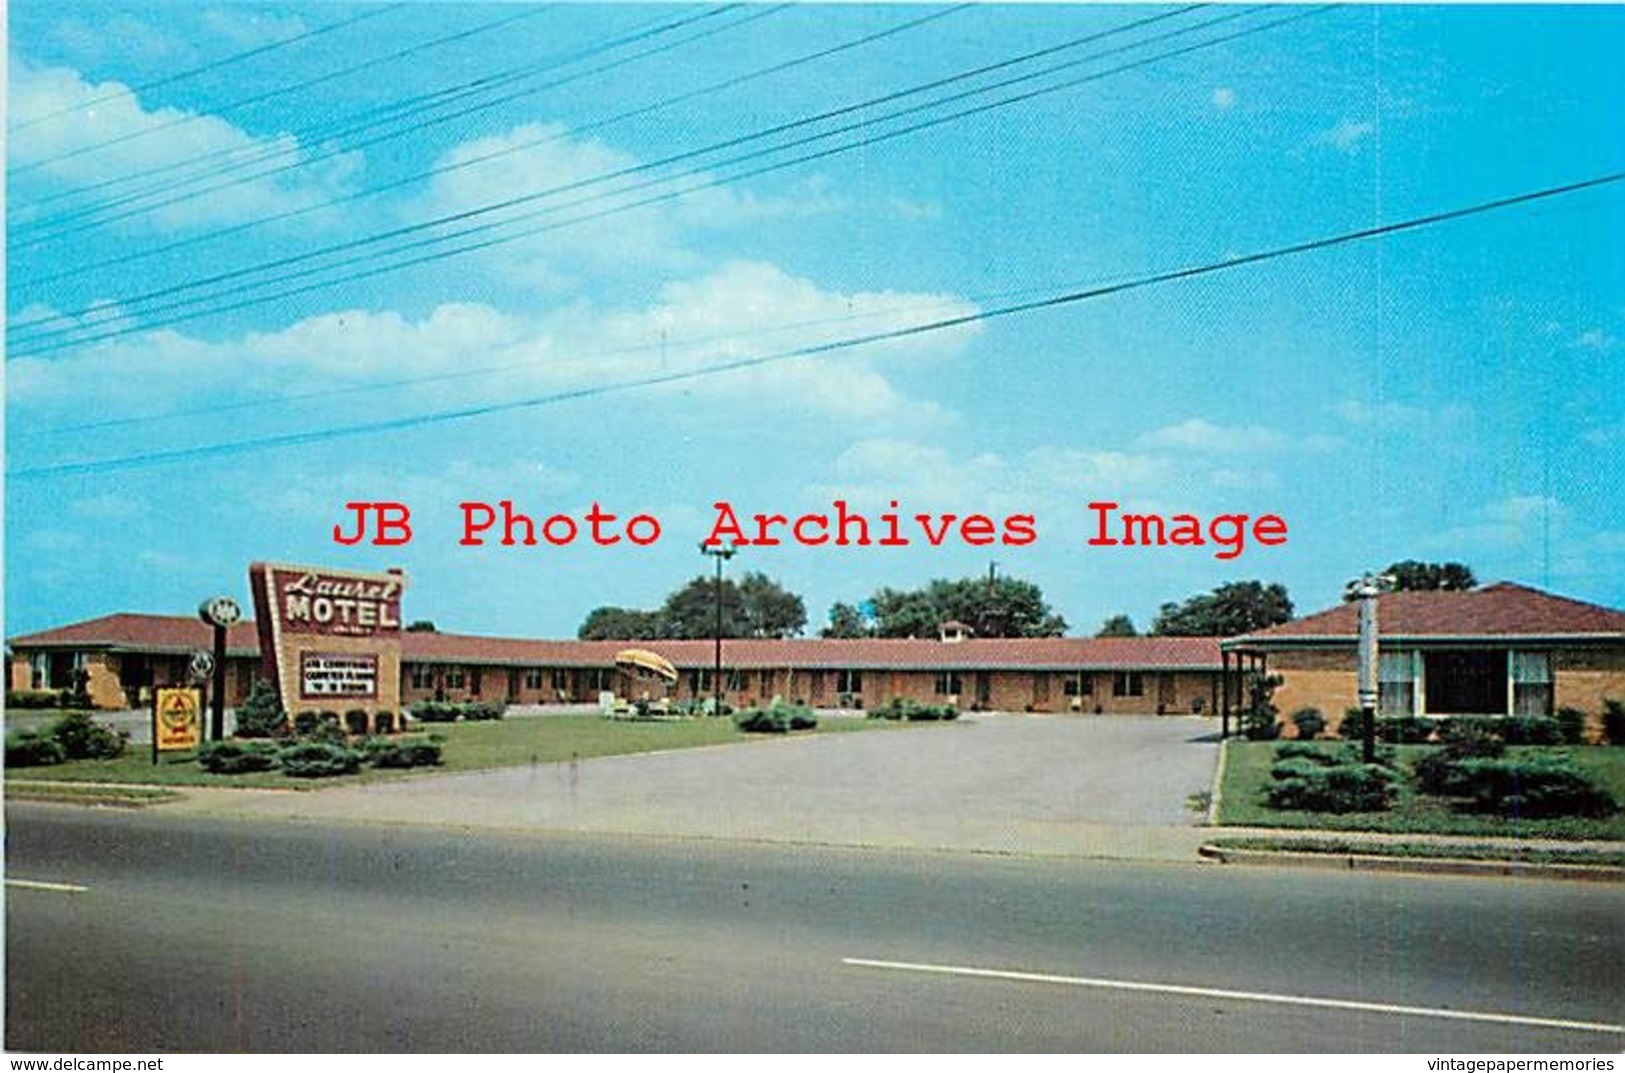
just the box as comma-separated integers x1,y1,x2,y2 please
7,60,361,229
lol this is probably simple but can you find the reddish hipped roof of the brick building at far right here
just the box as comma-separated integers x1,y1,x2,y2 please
1225,582,1625,649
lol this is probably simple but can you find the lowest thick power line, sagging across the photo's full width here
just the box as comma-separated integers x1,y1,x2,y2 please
8,171,1625,480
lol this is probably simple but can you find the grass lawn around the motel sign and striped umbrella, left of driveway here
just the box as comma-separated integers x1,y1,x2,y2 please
7,715,930,790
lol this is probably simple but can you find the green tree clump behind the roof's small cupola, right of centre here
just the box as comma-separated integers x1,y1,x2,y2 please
851,577,1066,637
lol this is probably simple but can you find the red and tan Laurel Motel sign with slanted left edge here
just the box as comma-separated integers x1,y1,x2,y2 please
249,563,406,730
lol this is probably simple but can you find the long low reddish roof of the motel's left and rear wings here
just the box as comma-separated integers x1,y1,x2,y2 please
11,615,1219,670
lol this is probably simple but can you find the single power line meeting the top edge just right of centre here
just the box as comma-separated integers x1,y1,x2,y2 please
15,3,972,289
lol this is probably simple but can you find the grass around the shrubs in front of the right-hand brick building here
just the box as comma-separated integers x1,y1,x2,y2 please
1219,741,1625,841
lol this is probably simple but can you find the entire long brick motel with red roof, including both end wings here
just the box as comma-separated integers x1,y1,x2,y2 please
8,582,1625,728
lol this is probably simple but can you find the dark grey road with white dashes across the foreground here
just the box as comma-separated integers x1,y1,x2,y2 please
7,805,1625,1052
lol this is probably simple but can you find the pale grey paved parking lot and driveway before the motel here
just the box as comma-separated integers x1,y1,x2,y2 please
155,715,1219,860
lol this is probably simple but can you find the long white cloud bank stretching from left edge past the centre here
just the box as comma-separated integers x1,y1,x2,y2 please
8,262,980,428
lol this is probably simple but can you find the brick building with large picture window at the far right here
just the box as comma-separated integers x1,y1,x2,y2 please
1222,582,1625,727
